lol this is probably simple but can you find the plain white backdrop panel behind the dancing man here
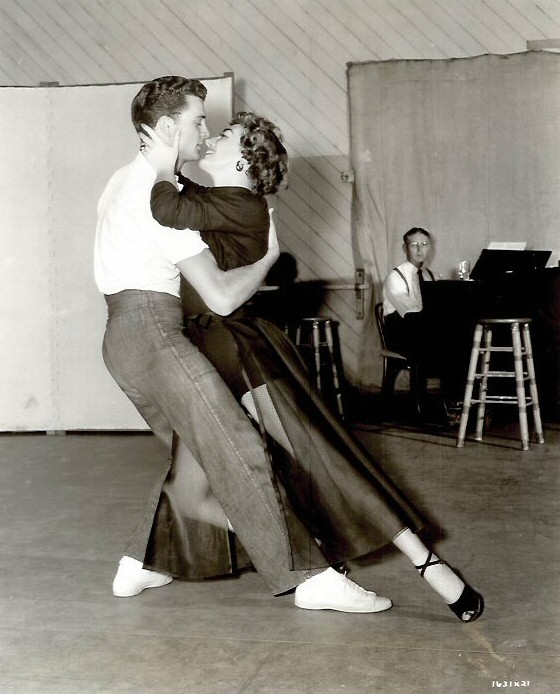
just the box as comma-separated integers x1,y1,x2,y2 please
0,75,233,431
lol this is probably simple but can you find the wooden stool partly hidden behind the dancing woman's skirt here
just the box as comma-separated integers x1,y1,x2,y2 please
286,318,344,417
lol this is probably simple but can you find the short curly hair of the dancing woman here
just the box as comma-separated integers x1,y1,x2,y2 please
230,111,288,195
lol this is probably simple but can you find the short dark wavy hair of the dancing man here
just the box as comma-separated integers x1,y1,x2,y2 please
130,75,207,132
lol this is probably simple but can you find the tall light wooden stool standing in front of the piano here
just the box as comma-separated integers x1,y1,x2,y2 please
457,318,544,451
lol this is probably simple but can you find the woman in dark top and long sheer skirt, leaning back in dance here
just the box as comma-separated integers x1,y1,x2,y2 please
142,112,484,622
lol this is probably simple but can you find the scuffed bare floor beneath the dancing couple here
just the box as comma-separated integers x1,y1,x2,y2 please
0,408,560,694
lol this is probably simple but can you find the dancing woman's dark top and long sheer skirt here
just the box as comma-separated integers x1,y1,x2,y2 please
145,181,423,578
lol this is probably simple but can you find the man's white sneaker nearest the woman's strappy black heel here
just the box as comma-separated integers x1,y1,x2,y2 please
295,568,393,613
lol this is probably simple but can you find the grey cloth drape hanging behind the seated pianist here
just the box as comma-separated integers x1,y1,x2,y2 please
348,52,560,386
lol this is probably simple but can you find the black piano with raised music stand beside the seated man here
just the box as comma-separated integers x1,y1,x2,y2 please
423,249,560,422
